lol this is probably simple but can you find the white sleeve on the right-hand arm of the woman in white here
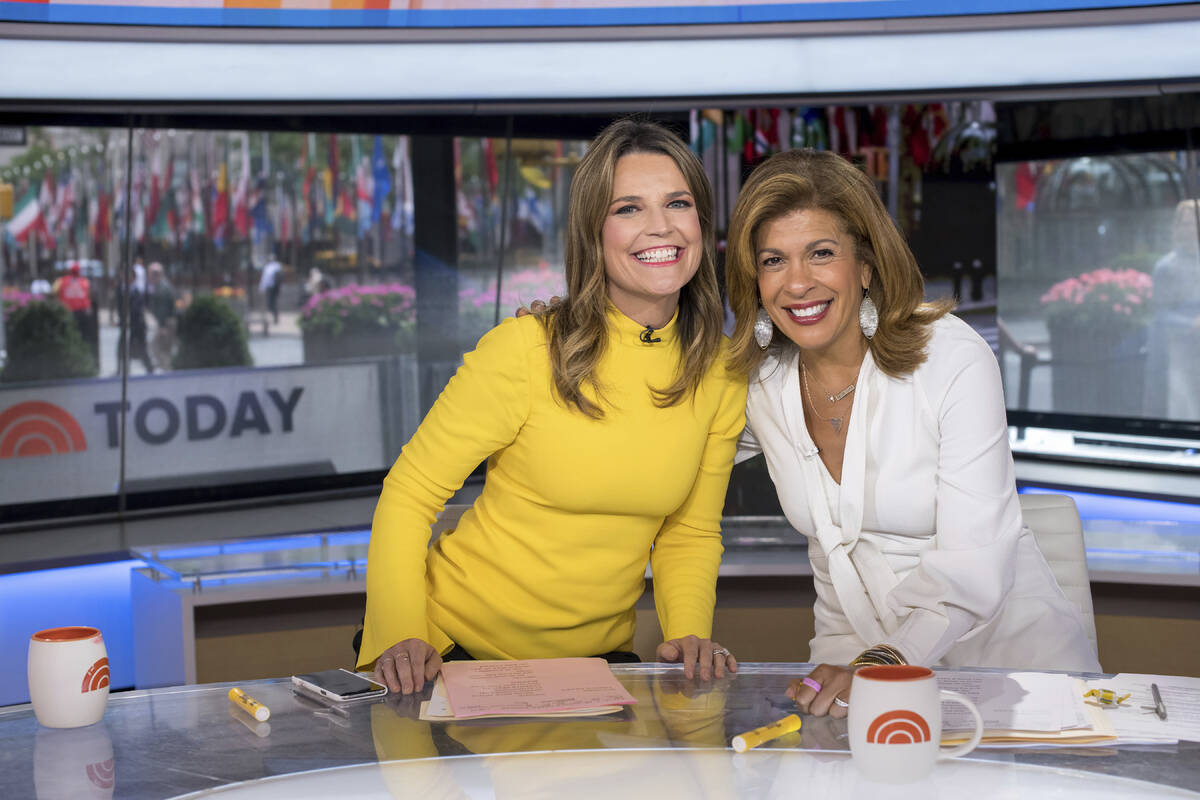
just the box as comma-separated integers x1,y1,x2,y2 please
888,328,1022,663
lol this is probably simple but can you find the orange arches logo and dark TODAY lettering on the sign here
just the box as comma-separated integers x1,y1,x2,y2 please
0,386,304,458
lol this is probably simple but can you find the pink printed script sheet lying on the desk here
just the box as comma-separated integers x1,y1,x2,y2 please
442,658,637,718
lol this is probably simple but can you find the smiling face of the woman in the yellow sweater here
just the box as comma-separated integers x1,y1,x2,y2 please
601,152,703,327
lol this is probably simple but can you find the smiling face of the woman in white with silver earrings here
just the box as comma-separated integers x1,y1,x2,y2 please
755,209,871,361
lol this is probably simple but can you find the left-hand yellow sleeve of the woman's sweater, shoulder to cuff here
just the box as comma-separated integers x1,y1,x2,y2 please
358,317,544,669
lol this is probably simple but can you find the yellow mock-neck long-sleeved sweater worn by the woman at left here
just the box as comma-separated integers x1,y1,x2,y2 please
359,308,746,669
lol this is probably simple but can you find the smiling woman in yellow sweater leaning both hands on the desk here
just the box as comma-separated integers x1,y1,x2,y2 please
359,120,746,693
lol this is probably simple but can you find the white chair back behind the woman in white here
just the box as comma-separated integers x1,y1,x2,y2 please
1019,494,1098,652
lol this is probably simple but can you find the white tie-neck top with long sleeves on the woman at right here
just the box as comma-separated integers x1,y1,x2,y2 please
738,315,1100,670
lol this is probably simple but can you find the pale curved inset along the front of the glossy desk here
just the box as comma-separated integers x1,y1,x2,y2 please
174,750,1200,800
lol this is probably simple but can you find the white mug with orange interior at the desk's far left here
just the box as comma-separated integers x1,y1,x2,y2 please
29,626,108,728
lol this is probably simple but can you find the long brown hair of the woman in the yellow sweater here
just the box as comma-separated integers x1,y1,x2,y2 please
539,119,724,417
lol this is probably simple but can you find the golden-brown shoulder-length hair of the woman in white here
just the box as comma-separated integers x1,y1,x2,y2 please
726,149,953,378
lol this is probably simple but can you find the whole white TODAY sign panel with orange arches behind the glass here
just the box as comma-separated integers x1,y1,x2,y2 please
0,363,390,505
